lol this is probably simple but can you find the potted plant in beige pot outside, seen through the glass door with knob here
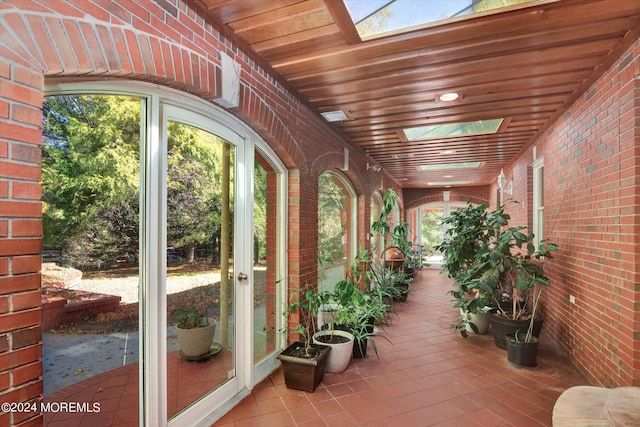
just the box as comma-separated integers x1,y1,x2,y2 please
173,295,216,360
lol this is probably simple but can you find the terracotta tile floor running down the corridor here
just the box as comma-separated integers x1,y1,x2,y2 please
214,269,589,427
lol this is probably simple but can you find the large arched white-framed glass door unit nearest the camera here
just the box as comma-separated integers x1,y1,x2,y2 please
43,82,287,426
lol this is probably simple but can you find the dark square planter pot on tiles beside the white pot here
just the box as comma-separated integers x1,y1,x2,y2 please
278,342,331,393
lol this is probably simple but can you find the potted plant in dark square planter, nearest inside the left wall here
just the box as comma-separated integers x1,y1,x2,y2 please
278,285,331,393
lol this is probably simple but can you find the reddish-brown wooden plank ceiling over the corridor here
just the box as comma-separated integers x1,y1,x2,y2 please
189,0,640,188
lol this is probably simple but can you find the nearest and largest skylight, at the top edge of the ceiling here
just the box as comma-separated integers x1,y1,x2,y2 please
343,0,556,39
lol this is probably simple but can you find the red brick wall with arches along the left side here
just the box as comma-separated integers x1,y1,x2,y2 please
0,0,398,425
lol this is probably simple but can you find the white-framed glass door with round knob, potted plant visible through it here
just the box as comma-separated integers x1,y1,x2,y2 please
158,105,248,425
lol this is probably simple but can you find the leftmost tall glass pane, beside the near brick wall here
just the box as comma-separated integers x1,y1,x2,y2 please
42,95,145,425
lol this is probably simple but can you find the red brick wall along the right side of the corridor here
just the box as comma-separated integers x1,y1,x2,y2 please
505,41,640,387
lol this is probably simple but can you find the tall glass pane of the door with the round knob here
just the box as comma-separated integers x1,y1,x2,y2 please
167,122,235,417
